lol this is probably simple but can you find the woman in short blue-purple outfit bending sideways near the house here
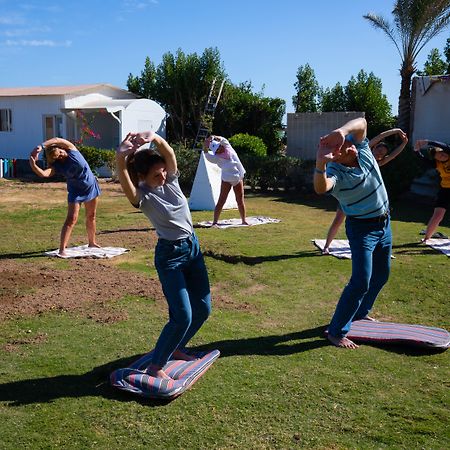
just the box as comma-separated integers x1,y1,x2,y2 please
30,138,101,256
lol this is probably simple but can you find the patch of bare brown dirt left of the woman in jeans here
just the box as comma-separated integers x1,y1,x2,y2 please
0,259,164,323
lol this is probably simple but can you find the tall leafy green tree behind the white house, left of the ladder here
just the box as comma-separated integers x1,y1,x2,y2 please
127,48,226,142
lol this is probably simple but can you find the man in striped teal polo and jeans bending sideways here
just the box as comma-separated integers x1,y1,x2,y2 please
314,118,392,349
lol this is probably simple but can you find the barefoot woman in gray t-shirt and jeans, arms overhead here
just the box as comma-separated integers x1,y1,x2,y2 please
116,131,211,378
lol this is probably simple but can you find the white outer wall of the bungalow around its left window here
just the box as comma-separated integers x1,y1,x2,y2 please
0,96,65,159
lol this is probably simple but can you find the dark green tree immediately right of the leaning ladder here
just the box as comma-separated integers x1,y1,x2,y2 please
214,82,286,154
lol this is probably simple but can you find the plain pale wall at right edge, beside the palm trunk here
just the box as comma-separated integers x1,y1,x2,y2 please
410,76,450,143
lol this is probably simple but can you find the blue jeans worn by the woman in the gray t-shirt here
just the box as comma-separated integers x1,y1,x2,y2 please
152,234,211,367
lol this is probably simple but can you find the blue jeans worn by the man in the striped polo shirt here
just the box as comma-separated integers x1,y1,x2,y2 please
328,217,392,337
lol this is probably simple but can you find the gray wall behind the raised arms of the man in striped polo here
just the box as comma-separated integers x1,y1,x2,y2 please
286,111,364,160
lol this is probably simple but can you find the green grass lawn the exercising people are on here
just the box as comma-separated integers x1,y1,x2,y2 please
0,181,450,449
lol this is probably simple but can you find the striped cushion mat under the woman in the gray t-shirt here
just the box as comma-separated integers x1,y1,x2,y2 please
110,350,220,400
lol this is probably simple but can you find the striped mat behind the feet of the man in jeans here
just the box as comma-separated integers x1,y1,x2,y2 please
340,320,450,349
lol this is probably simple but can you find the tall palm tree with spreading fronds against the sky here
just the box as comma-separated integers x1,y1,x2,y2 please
364,0,450,133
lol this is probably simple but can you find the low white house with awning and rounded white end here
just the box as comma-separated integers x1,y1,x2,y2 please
0,84,166,159
